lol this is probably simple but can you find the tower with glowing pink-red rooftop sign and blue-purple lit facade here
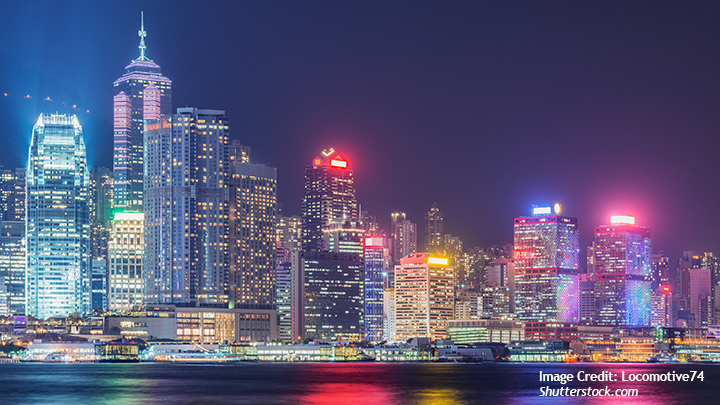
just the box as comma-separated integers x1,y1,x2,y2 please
595,215,652,326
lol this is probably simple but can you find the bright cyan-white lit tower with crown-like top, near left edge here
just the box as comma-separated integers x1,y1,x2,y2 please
26,114,90,319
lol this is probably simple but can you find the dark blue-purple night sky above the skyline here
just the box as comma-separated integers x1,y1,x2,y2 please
0,1,720,267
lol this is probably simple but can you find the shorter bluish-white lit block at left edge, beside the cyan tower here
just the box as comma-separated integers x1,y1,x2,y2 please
0,221,25,315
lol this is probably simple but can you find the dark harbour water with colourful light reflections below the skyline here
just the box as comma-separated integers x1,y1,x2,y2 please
0,363,720,405
